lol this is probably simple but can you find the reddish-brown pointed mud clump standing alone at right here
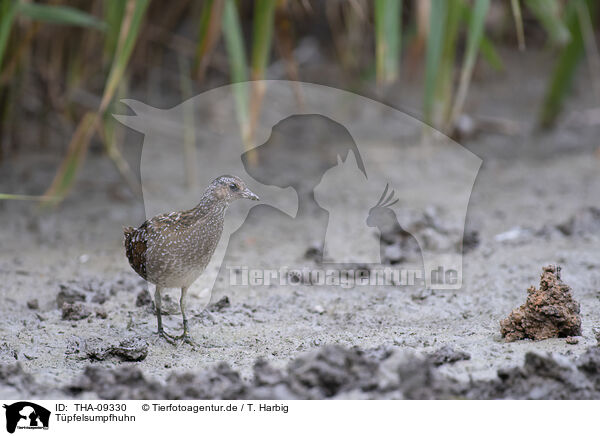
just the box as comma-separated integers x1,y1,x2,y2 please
500,265,581,342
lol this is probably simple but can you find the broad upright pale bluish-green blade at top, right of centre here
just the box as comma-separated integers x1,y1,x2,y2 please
375,0,402,85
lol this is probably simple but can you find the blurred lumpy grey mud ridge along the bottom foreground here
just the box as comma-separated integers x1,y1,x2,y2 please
29,345,600,400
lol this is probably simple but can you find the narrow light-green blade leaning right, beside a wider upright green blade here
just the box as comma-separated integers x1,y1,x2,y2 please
447,0,490,130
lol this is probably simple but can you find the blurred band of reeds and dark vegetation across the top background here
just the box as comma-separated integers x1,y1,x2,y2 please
0,0,600,203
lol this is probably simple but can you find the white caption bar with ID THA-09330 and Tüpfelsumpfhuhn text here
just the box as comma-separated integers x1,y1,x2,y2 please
2,400,598,436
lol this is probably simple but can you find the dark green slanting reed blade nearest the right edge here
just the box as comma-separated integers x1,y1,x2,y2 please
539,0,596,127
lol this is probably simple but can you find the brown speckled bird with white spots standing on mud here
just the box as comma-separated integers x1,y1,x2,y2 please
123,175,259,346
